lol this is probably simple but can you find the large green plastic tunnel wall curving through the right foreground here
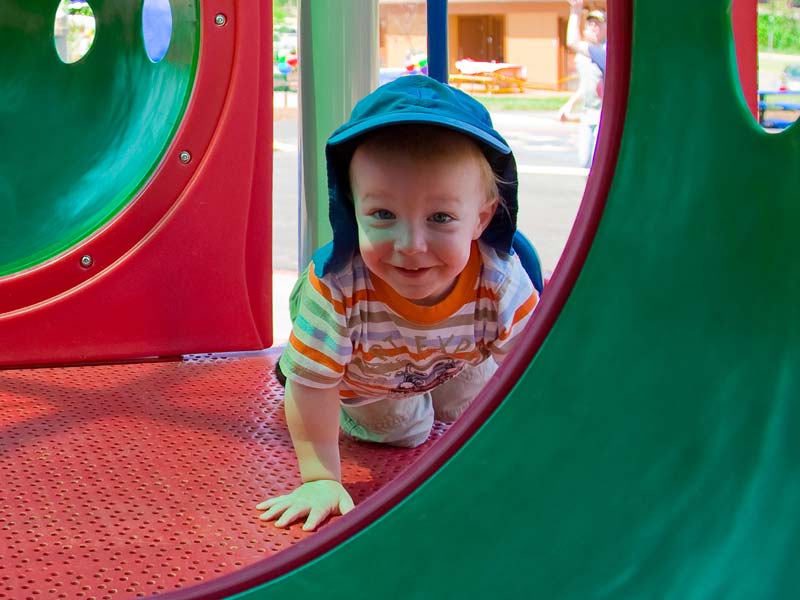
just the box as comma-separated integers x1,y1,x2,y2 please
230,0,800,600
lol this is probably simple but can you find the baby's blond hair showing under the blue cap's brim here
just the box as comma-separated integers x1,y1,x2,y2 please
350,123,505,209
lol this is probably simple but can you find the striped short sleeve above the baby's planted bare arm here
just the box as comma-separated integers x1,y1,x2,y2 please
280,264,353,388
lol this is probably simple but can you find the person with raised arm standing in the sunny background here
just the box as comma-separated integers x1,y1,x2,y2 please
558,0,606,168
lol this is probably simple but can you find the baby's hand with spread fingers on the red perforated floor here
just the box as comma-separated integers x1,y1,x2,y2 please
256,479,354,531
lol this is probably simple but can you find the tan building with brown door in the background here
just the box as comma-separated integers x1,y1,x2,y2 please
379,0,606,89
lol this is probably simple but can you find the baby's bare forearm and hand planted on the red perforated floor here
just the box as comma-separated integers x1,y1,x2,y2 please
256,380,353,531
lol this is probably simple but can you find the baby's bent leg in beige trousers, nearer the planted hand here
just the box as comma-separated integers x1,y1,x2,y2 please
339,393,433,448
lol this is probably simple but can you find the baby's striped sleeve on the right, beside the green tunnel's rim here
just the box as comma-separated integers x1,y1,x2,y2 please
489,251,539,363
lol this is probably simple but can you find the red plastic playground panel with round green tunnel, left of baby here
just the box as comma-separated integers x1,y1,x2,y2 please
0,0,272,366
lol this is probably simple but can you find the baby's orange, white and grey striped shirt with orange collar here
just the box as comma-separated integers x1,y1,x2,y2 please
280,242,539,405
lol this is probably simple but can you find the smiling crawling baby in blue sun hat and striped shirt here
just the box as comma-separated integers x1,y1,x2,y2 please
257,75,539,530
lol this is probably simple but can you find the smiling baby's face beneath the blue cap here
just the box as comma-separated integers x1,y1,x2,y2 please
350,146,495,305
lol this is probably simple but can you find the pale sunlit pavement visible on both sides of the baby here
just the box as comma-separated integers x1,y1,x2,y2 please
273,92,587,343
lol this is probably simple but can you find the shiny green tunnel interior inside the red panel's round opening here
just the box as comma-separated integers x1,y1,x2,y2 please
0,0,199,276
